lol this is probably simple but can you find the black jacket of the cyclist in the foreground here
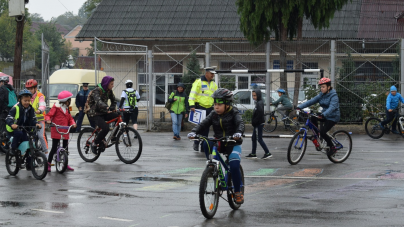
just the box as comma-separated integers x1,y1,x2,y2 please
192,107,245,153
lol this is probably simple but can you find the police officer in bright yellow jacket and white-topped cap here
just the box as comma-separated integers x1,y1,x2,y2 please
188,66,217,151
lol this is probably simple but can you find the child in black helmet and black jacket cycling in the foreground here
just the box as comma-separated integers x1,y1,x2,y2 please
188,88,244,204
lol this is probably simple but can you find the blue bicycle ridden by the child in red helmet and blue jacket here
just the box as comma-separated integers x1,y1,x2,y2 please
287,111,352,165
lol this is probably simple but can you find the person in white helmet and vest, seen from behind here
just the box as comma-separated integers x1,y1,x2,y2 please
119,80,140,135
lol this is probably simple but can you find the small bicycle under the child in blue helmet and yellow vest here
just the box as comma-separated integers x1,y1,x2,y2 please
5,126,48,180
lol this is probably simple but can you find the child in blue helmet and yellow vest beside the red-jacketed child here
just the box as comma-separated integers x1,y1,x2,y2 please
6,89,41,165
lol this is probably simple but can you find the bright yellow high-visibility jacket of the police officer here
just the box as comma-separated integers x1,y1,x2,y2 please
188,79,217,108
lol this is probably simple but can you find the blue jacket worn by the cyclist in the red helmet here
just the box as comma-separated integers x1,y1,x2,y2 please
298,89,340,122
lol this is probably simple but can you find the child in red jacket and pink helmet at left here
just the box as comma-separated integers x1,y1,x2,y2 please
45,91,76,172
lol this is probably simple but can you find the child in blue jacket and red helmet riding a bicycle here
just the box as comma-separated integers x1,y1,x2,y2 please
297,77,340,156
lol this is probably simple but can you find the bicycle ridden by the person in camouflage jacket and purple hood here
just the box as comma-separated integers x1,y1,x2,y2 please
77,109,143,164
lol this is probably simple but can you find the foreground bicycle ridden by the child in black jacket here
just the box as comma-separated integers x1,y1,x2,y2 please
192,135,244,219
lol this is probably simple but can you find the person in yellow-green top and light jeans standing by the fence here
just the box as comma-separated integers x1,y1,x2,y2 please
168,83,189,140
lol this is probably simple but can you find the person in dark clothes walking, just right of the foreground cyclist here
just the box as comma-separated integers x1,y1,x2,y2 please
246,89,272,159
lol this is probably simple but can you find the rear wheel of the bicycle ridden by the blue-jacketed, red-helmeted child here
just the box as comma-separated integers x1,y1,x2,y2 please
327,130,352,163
